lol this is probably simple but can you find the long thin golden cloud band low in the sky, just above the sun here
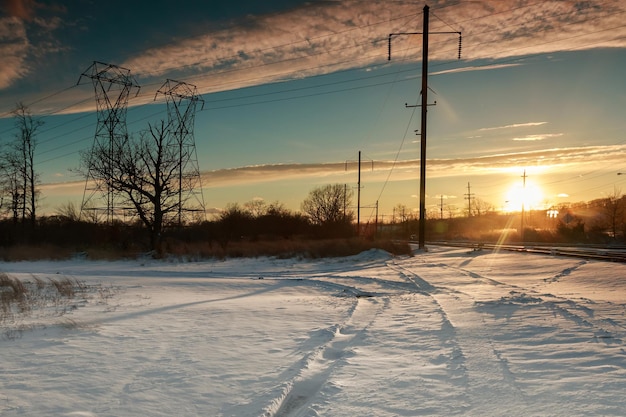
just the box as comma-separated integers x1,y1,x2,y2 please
40,145,626,211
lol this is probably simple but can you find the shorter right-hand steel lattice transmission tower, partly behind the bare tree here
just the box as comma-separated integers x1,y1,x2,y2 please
154,79,206,226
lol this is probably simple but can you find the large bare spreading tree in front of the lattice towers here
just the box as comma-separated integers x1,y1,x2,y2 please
81,121,192,251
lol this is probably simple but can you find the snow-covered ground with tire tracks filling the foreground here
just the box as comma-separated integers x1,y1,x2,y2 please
0,247,626,417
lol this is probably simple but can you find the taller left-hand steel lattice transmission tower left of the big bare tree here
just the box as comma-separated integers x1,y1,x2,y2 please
77,61,139,223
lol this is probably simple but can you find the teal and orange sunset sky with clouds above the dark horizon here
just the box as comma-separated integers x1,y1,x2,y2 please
0,0,626,220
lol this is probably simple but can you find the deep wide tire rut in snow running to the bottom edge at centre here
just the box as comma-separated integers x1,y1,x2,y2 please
263,292,386,417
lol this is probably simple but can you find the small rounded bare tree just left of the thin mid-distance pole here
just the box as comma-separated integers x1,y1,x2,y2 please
302,184,354,225
